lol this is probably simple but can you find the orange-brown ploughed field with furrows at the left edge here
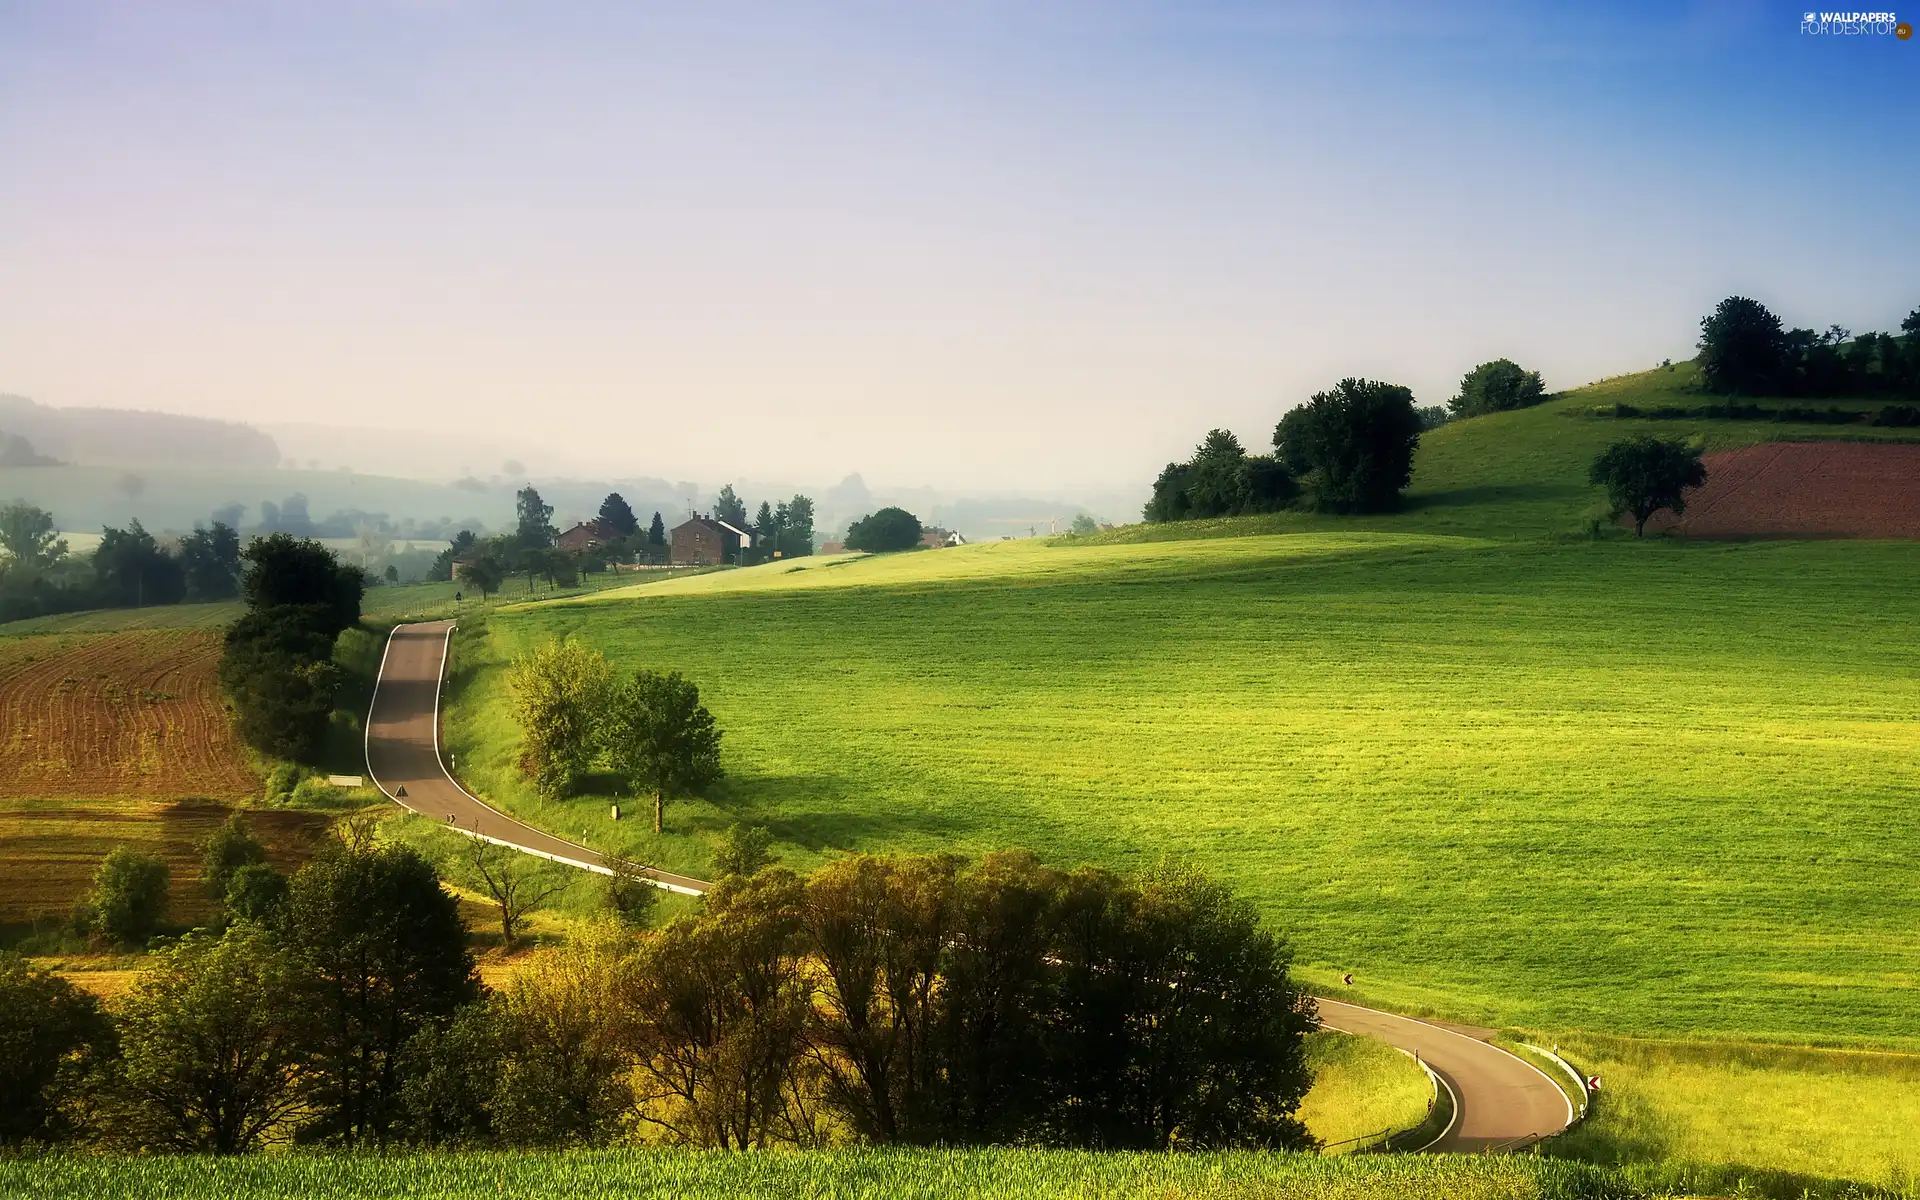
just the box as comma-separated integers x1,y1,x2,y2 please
0,630,261,801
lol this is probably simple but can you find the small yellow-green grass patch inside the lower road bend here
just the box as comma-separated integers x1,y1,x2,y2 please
1300,1031,1432,1154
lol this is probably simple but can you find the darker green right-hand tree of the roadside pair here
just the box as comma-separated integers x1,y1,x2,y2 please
605,670,724,833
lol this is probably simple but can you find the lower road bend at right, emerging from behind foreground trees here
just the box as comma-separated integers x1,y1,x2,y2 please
1319,996,1572,1154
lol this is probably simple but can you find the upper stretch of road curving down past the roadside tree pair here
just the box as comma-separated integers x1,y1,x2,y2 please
367,620,707,897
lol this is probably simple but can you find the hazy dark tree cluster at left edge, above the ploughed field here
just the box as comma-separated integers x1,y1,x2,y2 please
0,501,242,620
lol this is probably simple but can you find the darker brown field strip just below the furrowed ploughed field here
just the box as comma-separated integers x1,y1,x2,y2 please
0,799,330,929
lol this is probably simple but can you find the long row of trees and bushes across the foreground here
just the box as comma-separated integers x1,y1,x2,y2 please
0,821,1315,1154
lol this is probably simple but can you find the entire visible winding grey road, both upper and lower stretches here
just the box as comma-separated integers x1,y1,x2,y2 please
367,620,1574,1154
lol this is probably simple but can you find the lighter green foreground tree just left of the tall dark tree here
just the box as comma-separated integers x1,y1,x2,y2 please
117,924,309,1154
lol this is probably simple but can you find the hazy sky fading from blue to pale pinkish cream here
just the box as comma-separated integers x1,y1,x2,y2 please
0,0,1920,488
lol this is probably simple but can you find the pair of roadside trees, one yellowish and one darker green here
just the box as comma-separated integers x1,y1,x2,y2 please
507,637,722,833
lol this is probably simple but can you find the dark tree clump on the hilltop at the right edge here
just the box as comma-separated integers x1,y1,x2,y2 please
1699,296,1920,399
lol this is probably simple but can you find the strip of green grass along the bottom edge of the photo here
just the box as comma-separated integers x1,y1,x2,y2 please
0,1150,1645,1200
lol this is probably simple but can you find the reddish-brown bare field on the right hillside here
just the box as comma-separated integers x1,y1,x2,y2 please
1647,442,1920,538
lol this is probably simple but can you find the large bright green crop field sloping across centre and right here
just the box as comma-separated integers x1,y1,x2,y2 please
447,534,1920,1046
